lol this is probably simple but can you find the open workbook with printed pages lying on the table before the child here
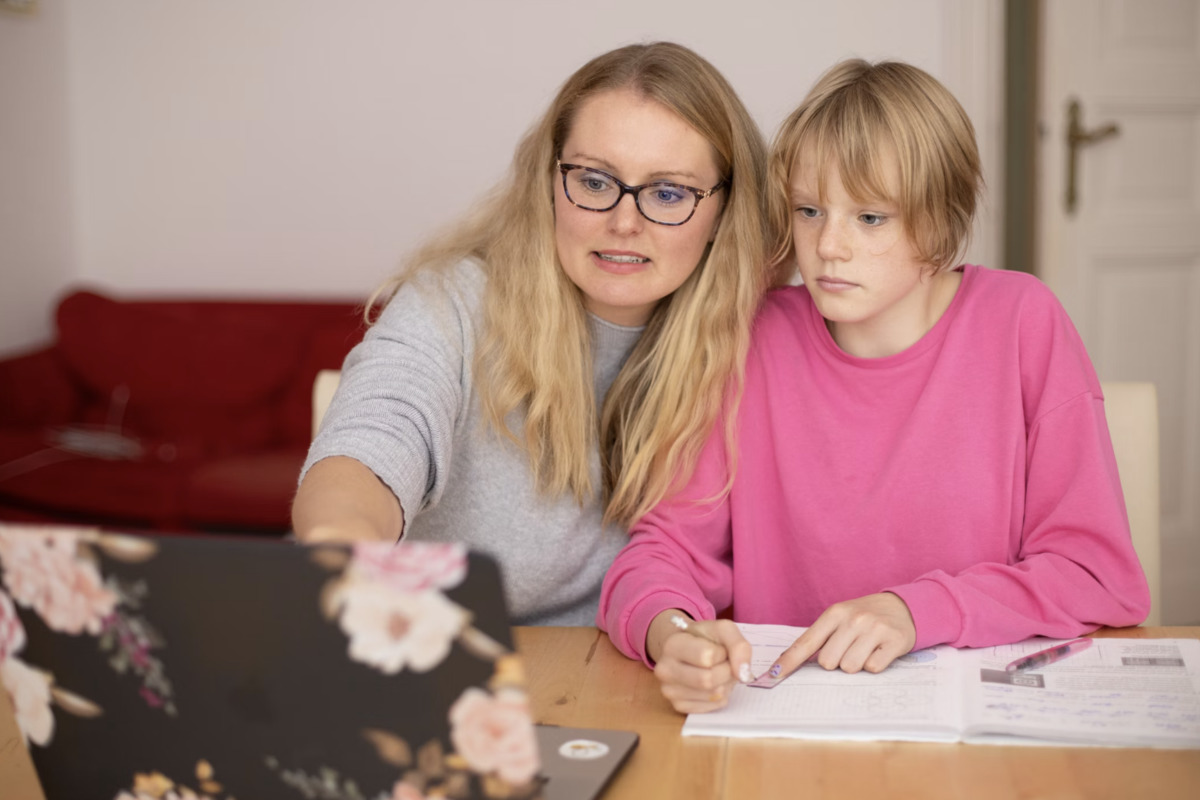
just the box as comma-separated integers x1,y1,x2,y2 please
683,624,1200,747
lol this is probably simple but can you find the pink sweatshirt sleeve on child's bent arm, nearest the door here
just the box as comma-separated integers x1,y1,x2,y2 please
888,284,1150,649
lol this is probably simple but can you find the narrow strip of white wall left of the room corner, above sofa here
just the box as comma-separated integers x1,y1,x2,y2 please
0,2,74,353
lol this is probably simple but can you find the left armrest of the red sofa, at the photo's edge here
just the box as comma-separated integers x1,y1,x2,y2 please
0,347,82,427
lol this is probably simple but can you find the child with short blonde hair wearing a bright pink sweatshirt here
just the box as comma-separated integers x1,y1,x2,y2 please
598,60,1150,712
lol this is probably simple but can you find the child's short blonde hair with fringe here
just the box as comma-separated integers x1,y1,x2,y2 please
767,59,983,271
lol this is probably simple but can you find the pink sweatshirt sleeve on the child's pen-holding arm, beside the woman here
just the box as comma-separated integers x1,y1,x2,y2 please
596,426,733,667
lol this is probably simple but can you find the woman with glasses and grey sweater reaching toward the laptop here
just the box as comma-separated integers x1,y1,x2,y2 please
293,42,768,625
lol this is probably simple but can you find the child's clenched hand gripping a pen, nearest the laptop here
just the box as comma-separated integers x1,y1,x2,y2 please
646,610,751,714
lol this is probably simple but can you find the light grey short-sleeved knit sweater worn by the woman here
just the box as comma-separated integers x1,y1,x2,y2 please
301,261,642,625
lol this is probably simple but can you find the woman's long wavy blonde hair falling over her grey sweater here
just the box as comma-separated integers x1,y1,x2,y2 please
376,42,769,532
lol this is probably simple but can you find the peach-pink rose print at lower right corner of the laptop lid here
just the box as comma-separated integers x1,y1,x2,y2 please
450,686,540,784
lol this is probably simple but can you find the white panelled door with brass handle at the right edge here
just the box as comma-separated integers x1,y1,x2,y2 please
1038,0,1200,625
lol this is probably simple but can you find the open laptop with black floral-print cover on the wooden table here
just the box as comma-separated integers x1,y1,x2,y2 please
0,524,637,800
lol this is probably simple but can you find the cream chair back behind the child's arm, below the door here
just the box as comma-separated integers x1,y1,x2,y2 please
1100,381,1163,625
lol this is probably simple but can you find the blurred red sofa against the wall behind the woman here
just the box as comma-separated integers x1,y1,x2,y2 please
0,290,364,533
